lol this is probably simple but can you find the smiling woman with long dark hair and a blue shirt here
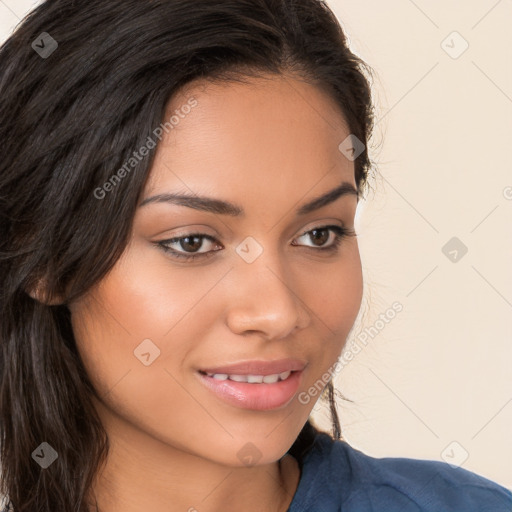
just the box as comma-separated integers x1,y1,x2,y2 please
0,0,512,512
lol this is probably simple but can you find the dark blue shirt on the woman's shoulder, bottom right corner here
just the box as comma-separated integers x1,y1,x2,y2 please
288,433,512,512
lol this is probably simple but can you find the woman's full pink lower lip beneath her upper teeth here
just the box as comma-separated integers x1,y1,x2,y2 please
197,371,302,411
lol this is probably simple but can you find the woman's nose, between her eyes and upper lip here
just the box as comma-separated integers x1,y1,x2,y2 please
226,247,311,340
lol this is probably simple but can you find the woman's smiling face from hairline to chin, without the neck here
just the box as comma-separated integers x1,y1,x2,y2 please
70,73,362,466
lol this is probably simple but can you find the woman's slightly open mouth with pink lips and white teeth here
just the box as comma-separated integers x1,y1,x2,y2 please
196,360,306,411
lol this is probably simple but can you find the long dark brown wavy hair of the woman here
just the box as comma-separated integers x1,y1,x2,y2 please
0,0,374,512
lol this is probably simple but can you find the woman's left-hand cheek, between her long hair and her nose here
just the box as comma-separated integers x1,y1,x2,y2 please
66,246,223,421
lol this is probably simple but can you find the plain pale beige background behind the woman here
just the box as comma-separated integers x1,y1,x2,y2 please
0,0,512,489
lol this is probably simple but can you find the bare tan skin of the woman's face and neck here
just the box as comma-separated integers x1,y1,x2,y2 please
66,72,362,512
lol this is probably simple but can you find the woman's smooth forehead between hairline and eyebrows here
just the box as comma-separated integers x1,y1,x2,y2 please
142,75,355,204
